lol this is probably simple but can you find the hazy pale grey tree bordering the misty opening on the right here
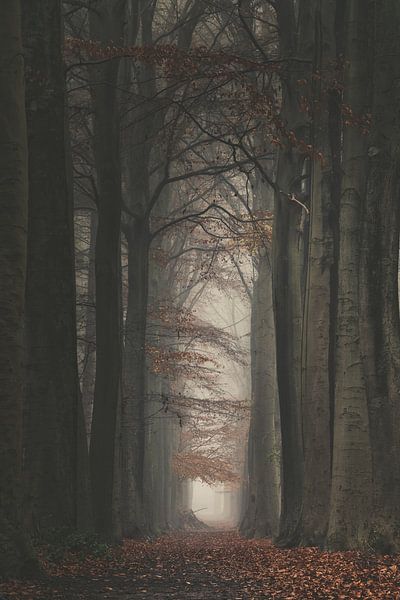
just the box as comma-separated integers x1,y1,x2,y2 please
238,0,280,537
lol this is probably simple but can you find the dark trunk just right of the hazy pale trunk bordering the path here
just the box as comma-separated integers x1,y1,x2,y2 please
272,1,314,545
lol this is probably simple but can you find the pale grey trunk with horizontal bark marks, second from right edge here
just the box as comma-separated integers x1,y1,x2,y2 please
327,0,372,550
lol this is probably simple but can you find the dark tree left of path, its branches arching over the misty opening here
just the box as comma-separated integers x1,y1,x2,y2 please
121,0,204,535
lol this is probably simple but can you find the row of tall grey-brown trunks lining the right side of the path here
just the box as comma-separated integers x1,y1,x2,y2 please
242,0,399,552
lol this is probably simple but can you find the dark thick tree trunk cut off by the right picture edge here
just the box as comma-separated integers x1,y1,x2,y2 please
360,1,400,553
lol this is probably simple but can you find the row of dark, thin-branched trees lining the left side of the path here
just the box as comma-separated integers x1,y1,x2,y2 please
0,0,253,575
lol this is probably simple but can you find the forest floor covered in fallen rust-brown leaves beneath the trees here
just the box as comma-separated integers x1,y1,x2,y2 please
0,530,400,600
